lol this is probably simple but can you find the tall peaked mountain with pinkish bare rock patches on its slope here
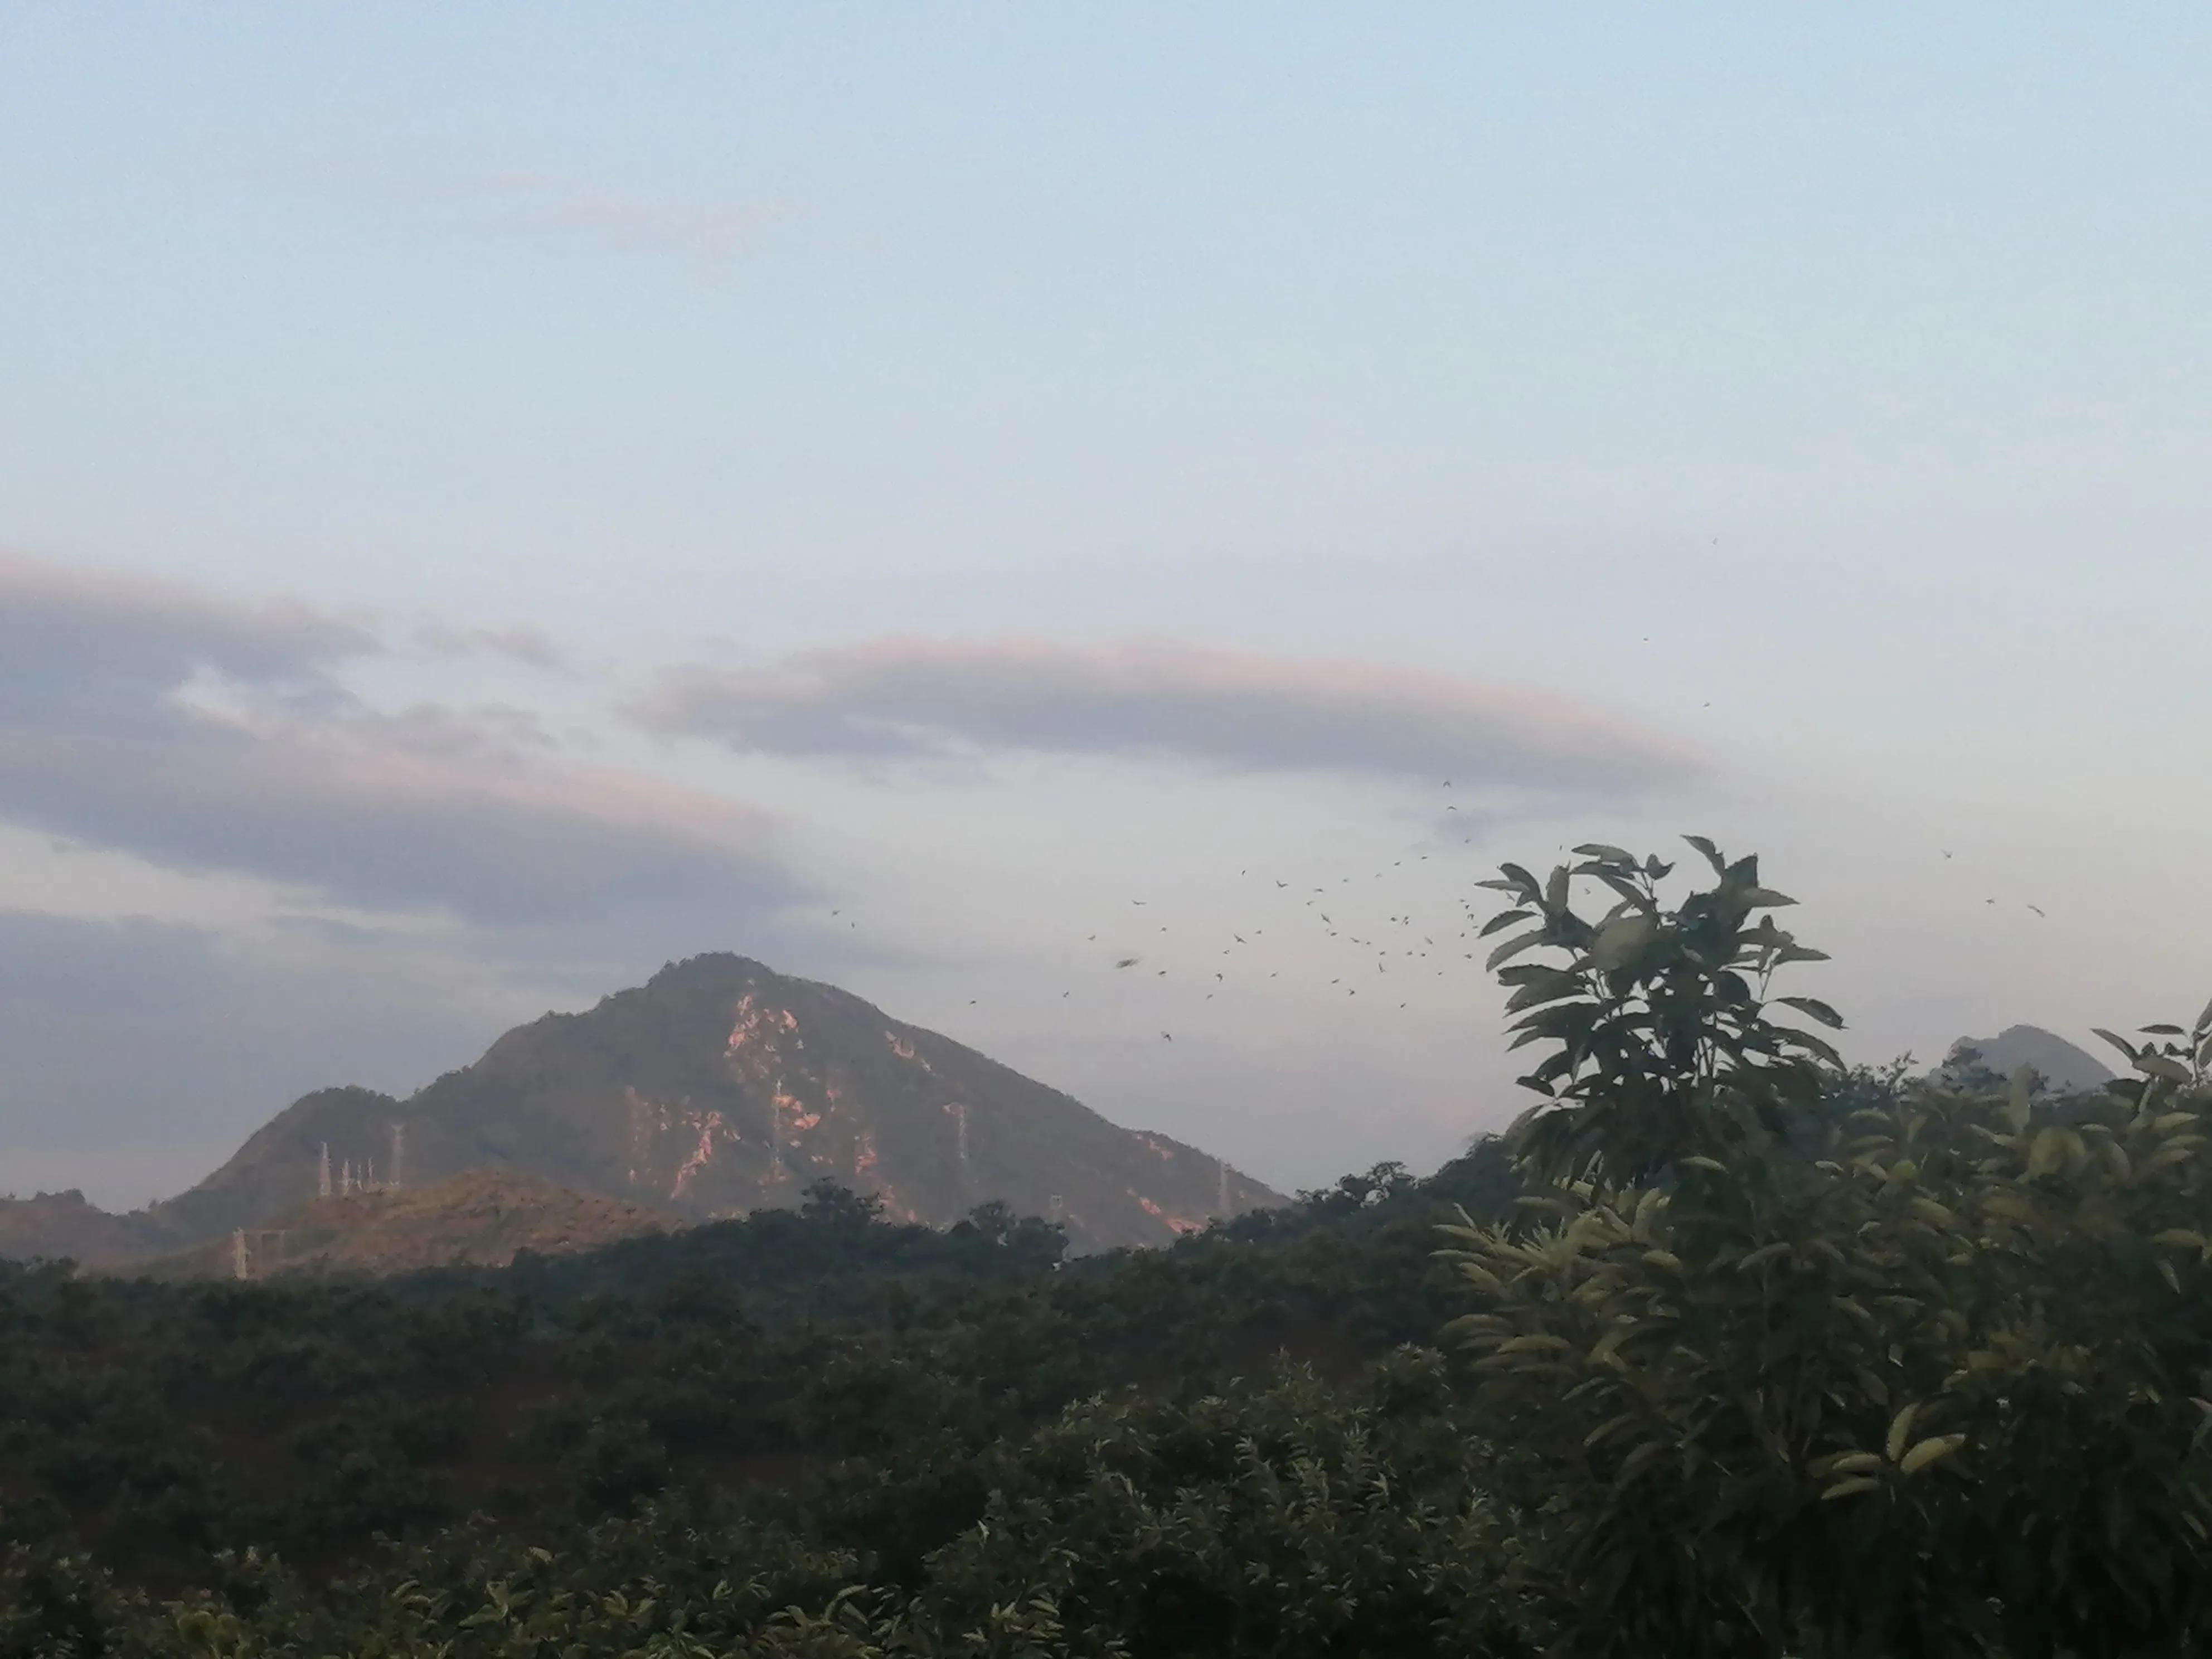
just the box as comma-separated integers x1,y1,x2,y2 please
0,955,1283,1261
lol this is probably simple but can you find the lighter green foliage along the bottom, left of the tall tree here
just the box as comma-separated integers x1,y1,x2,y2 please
0,1351,1531,1659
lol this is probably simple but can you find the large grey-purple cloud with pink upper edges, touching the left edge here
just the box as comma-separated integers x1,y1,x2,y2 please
0,560,794,923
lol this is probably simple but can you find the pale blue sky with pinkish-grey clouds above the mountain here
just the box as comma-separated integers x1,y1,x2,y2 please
0,0,2212,1206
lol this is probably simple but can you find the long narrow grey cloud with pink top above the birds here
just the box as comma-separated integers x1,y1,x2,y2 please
628,639,1696,794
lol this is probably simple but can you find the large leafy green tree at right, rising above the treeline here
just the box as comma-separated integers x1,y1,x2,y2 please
1447,843,2212,1657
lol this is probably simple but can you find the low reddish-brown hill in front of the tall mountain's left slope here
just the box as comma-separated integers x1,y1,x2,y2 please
115,1170,681,1279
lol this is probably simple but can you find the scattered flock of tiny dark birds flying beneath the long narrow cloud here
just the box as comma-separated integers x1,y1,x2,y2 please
830,779,2046,1042
